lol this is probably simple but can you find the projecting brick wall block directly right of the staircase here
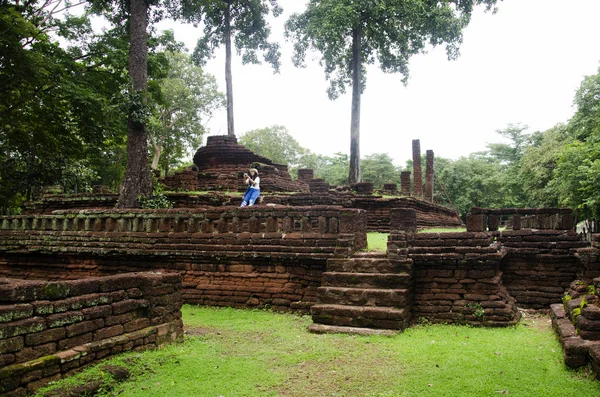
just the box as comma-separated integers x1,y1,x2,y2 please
408,232,520,326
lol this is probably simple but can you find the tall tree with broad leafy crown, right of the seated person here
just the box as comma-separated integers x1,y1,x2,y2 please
285,0,497,183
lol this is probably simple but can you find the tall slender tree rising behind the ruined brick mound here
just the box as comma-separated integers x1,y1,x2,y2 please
180,0,282,136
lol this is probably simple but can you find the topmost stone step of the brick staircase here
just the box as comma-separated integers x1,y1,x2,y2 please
327,256,412,273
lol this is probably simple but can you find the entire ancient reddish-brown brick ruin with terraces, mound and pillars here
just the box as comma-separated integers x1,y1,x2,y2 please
0,137,600,386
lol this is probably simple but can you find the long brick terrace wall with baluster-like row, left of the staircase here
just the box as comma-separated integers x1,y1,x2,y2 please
0,207,366,311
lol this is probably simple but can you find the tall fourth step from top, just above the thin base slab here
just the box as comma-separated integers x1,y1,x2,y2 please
310,304,407,329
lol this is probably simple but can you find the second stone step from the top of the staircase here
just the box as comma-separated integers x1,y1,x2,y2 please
323,272,411,289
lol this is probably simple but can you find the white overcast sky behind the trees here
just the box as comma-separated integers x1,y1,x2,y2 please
159,0,600,165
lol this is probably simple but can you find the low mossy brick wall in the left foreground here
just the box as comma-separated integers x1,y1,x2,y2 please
0,273,183,395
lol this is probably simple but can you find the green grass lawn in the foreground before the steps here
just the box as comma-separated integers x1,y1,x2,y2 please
40,305,600,397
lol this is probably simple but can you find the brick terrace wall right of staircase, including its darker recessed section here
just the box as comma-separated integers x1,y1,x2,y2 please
409,230,588,322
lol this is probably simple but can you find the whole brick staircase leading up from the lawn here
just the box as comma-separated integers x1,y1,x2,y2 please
309,232,412,334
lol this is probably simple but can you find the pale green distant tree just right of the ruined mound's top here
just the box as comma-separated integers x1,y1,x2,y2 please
240,125,308,168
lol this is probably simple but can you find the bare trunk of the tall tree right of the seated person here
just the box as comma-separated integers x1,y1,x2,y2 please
348,25,362,184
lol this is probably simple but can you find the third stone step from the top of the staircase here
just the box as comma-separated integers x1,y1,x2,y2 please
317,287,410,307
